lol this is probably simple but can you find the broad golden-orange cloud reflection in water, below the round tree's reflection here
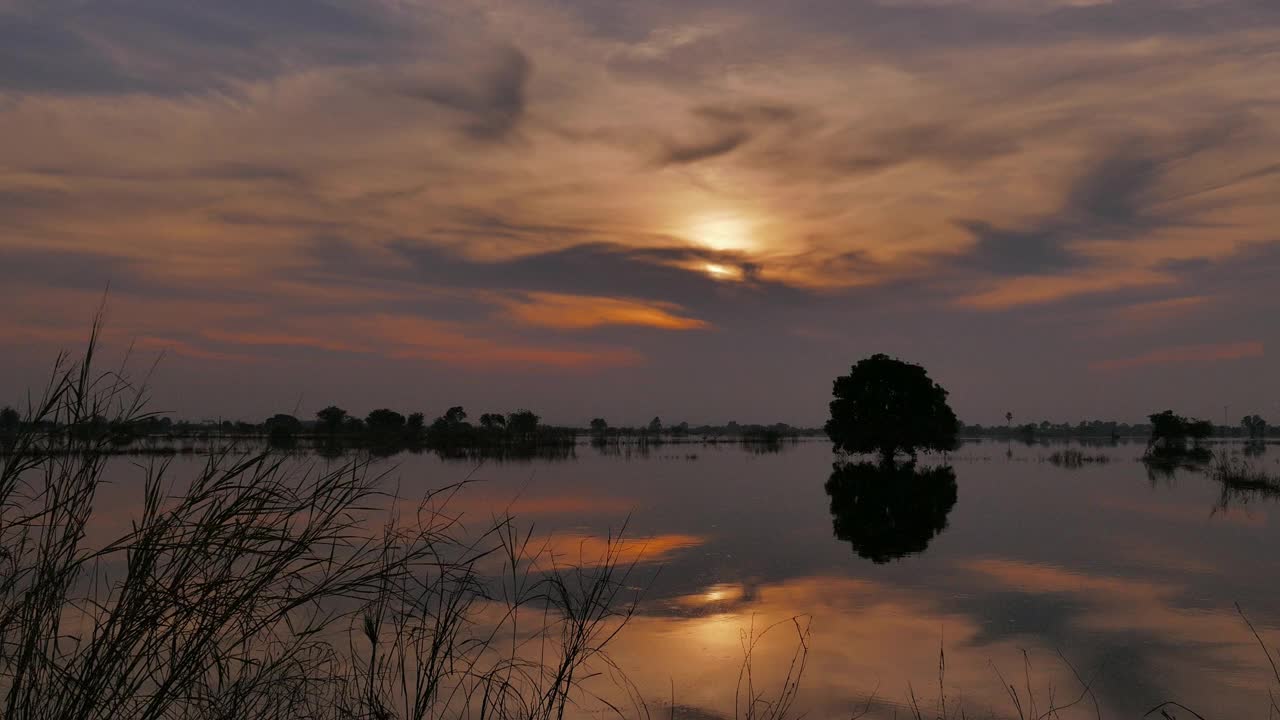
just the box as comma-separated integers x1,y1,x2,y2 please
612,577,1069,717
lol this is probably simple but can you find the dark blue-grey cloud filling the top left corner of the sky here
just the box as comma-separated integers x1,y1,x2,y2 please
0,0,411,94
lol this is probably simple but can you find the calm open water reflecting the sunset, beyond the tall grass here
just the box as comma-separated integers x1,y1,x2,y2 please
94,441,1280,717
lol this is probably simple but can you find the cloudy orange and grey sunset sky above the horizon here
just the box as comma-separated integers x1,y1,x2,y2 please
0,0,1280,425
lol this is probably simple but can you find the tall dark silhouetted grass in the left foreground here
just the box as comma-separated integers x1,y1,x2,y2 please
0,313,635,720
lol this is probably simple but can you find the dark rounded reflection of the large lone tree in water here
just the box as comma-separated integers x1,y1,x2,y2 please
827,462,957,562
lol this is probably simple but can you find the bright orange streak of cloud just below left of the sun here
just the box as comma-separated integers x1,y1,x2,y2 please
508,292,708,331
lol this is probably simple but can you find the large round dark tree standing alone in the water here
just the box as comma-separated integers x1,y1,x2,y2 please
824,355,960,464
